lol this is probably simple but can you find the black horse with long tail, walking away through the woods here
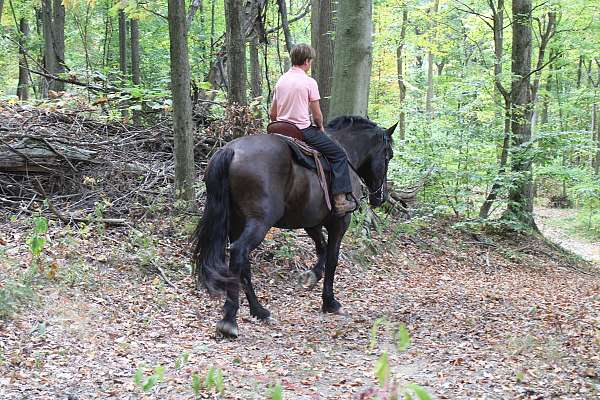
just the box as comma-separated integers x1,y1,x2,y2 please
193,116,396,337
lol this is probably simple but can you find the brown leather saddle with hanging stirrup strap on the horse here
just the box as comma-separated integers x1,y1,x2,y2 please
267,121,331,211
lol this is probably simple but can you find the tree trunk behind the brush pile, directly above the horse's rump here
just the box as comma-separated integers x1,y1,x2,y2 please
225,0,246,105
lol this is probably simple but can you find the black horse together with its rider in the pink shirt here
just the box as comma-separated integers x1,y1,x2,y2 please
193,45,396,337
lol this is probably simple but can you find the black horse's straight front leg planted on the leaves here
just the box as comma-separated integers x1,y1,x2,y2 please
322,216,350,314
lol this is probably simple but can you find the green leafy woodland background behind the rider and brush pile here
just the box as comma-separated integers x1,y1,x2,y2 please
0,0,600,237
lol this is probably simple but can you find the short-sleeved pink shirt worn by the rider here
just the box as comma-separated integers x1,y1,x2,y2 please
274,66,321,129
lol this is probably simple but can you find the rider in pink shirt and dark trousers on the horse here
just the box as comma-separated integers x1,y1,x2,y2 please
269,44,356,216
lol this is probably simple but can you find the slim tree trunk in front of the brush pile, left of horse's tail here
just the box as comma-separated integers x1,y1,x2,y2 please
168,0,195,202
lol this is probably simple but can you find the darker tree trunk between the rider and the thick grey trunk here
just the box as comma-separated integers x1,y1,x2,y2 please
311,0,335,123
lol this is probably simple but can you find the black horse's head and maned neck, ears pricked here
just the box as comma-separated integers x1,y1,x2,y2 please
328,117,398,207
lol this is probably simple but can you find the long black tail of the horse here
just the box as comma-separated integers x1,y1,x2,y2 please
193,148,234,293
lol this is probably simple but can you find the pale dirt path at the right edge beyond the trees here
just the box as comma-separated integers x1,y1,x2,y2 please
535,207,600,265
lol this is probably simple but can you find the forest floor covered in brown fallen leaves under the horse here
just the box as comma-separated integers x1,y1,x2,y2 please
0,211,600,399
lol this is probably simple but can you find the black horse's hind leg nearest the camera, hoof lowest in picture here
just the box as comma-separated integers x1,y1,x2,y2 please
217,220,268,337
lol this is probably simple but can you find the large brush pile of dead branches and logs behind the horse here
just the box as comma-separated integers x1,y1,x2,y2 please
0,102,263,223
